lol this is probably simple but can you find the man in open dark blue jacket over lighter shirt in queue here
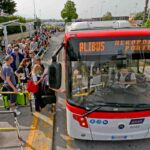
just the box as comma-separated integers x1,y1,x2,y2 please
11,46,24,71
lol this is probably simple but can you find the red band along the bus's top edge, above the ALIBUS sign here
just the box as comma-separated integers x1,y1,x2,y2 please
65,28,150,42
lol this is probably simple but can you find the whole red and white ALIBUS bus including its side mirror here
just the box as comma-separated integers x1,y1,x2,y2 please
49,23,150,140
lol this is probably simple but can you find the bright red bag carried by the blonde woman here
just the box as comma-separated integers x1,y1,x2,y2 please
27,80,39,93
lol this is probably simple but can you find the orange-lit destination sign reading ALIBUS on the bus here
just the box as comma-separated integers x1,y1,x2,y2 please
79,39,150,54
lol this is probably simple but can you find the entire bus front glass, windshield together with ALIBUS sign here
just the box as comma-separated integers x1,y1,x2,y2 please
67,33,150,111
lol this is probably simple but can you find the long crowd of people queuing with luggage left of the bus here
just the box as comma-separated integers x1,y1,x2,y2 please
0,30,51,115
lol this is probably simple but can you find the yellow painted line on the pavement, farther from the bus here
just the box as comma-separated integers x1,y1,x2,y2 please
25,112,40,150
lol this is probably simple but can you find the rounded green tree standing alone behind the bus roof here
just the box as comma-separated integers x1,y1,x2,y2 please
61,0,78,23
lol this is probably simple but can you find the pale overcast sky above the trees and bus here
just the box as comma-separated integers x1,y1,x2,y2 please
14,0,150,19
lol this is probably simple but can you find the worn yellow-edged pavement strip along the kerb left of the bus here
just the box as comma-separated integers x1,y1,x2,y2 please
25,110,54,150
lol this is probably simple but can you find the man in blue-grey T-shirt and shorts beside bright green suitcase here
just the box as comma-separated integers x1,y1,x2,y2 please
2,55,20,115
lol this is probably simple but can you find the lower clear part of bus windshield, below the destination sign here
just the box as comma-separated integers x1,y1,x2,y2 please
69,58,150,111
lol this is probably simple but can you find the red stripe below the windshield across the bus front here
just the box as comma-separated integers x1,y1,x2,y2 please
66,103,150,119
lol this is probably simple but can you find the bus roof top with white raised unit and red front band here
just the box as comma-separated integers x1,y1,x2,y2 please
65,21,150,41
